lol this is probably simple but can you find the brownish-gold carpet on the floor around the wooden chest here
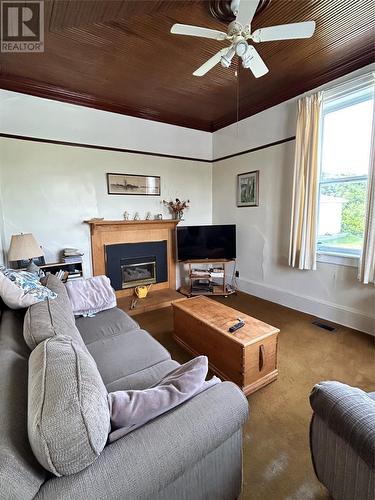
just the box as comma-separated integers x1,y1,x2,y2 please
136,293,375,500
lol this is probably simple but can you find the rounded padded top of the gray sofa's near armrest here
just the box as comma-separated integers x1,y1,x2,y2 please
36,382,248,500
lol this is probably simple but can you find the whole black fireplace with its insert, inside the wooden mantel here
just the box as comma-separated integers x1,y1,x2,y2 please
105,240,168,291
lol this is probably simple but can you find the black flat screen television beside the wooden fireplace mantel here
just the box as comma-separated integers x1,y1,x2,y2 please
177,224,236,261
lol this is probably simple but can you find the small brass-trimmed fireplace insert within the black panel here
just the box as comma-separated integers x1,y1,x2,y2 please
120,256,156,289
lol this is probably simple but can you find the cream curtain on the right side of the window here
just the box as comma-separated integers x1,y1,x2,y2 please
359,103,375,284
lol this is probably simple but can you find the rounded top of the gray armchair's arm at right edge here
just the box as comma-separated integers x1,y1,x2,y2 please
310,381,375,468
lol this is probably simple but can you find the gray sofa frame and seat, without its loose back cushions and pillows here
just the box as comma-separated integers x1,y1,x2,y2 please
0,276,248,500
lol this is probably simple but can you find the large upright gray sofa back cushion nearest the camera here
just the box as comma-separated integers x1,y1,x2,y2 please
27,335,110,476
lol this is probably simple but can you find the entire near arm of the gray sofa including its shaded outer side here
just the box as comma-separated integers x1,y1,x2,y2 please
36,382,248,500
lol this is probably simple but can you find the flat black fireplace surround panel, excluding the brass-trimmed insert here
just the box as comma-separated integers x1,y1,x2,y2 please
105,241,168,290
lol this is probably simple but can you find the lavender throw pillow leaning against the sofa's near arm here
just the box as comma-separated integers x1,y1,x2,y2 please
108,356,220,443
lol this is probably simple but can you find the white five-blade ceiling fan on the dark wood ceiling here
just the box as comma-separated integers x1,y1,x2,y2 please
171,0,315,78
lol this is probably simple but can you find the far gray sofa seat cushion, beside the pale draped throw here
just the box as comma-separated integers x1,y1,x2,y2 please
76,307,139,345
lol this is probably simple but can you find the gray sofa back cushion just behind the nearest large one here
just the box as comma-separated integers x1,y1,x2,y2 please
23,274,85,350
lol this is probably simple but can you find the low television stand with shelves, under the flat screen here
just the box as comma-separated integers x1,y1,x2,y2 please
179,259,235,297
